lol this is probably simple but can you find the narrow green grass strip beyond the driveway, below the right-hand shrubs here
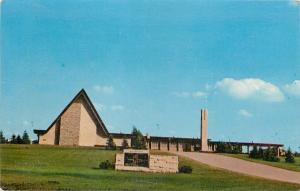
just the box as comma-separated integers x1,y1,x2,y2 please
222,153,300,172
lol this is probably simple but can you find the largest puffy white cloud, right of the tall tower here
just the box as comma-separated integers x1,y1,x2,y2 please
216,78,284,102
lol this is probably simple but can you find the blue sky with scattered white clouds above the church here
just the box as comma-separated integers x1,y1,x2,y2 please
0,0,300,151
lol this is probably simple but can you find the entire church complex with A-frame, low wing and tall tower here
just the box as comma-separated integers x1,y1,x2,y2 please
34,89,283,152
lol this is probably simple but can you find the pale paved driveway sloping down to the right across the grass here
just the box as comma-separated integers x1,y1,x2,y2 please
173,152,300,184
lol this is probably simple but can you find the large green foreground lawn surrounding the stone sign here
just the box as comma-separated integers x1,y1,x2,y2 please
0,145,300,191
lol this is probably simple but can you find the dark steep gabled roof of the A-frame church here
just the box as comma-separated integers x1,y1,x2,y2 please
33,89,109,136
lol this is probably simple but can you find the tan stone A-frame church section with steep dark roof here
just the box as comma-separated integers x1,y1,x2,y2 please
34,89,131,146
